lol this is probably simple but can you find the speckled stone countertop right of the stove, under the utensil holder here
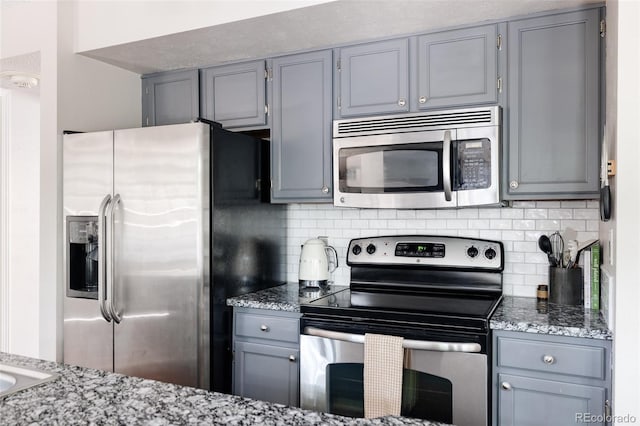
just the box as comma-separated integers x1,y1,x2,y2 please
490,296,613,340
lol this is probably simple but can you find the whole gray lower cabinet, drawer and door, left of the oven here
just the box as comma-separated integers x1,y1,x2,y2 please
233,308,300,406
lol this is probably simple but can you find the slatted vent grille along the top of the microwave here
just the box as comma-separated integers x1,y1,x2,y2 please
334,107,499,137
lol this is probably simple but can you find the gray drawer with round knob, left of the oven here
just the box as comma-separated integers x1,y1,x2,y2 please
235,313,300,343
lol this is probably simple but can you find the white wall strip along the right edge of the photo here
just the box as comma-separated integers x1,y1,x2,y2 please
608,0,640,419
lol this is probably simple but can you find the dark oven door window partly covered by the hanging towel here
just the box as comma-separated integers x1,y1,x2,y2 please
326,363,453,423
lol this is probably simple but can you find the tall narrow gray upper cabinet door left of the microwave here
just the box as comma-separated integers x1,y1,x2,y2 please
271,50,332,202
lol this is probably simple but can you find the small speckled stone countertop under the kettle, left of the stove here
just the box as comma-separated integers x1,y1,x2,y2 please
227,282,349,312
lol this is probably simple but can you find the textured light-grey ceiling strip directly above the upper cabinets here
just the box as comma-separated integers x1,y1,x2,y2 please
79,0,602,74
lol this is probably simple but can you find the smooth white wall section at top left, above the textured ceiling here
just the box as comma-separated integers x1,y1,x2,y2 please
74,0,328,52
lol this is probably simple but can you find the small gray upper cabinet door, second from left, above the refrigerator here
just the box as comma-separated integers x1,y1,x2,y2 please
200,61,267,128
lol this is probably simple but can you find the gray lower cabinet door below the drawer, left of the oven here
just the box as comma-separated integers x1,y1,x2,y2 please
233,342,299,406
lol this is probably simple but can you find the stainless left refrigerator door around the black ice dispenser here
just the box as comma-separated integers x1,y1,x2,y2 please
63,131,113,371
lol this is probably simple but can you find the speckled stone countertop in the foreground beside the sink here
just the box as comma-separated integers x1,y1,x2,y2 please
0,352,450,426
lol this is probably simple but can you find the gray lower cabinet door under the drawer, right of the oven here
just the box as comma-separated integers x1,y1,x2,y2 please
498,374,606,426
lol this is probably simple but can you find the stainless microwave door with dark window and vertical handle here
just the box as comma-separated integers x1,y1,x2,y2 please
333,129,457,208
